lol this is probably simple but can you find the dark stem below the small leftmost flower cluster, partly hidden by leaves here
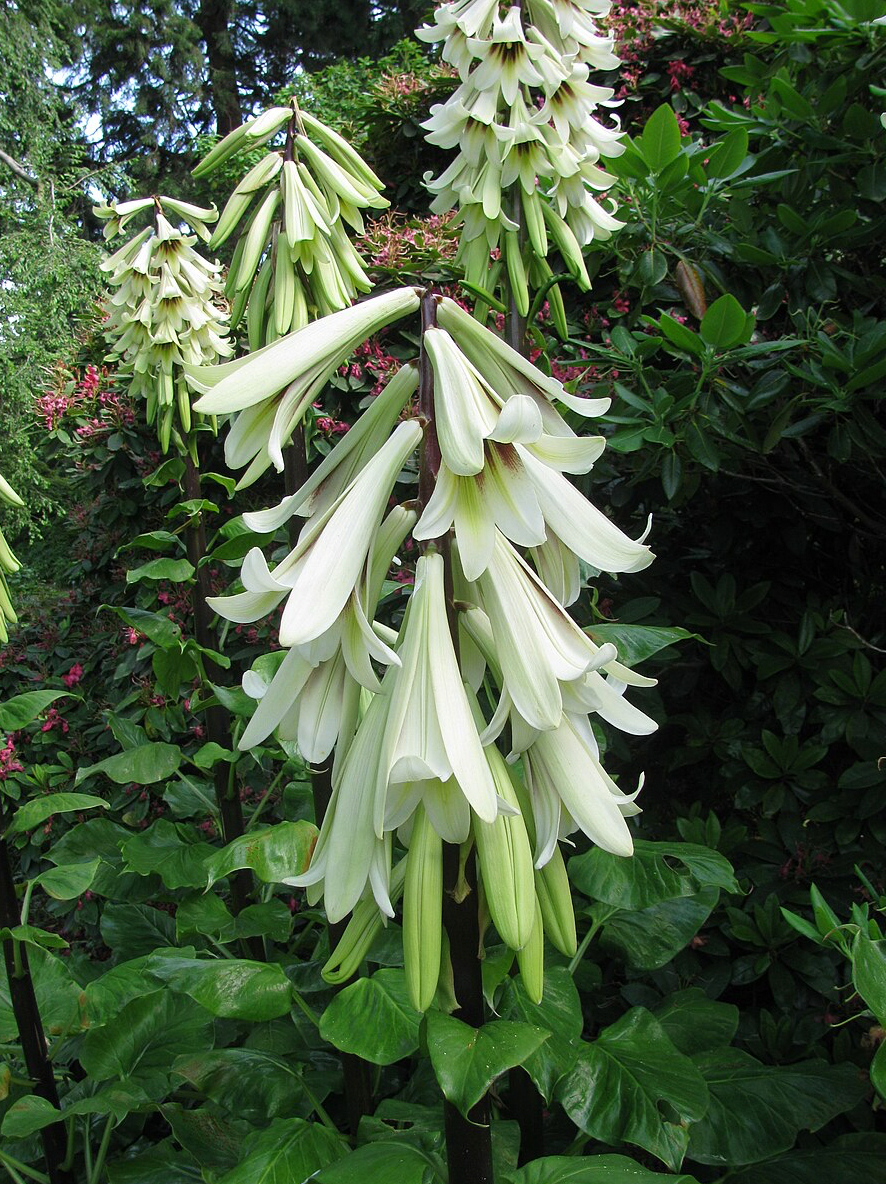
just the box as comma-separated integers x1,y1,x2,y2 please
185,456,264,961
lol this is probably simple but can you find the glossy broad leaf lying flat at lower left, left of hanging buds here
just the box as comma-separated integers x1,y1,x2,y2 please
152,958,293,1022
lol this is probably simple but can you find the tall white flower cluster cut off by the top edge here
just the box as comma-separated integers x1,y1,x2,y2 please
417,0,624,316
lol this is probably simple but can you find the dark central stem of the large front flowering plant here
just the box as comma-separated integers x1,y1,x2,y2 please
418,291,493,1184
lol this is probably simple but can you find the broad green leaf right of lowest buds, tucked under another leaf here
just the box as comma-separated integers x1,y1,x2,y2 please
591,888,720,970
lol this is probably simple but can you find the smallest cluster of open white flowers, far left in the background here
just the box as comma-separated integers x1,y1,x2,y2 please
95,198,232,452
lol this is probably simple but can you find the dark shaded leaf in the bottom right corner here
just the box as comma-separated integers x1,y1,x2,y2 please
728,1133,886,1184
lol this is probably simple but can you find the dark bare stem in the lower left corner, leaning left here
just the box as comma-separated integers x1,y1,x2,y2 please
0,839,72,1184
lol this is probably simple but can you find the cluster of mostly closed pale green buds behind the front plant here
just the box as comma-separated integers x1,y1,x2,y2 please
194,105,389,349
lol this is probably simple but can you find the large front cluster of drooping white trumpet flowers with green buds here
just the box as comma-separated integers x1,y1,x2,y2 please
203,290,655,1009
